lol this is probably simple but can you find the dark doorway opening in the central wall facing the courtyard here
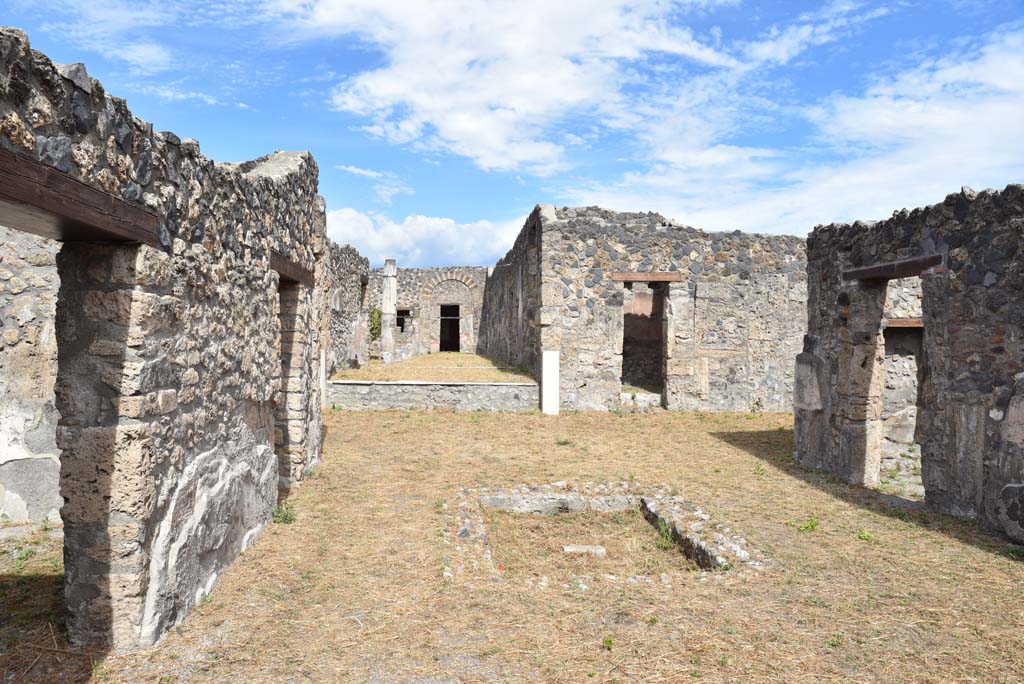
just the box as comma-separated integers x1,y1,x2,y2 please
622,283,668,395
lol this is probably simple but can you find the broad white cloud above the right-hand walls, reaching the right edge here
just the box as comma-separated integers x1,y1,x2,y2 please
566,28,1024,234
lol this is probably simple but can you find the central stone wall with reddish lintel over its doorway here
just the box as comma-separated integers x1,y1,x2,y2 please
481,207,806,411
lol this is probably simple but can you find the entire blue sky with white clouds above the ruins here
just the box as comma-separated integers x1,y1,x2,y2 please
0,0,1024,266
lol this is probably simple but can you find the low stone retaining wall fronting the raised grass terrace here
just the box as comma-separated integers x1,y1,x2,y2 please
327,380,540,413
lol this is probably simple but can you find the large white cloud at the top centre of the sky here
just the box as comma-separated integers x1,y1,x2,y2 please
264,0,738,175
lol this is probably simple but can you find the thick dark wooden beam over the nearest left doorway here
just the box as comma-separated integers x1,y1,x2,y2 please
0,147,160,249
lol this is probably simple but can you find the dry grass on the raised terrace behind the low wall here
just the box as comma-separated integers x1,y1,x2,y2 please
332,351,534,382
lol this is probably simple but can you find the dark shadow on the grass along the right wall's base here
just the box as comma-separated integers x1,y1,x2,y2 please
711,429,1024,562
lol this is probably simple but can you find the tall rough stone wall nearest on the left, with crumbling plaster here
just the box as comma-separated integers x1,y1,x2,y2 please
0,29,326,648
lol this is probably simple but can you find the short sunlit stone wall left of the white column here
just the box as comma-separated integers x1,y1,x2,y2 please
325,242,370,373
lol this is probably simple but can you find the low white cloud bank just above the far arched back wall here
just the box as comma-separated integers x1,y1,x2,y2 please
327,209,526,266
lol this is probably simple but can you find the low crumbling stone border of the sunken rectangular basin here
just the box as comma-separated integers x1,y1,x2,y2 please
443,481,768,582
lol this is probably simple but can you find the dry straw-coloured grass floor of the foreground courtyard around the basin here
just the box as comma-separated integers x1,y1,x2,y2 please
0,412,1024,684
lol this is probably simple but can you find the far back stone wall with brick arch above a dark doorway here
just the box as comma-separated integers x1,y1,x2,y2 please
364,266,487,360
